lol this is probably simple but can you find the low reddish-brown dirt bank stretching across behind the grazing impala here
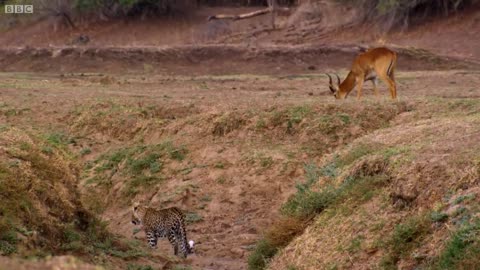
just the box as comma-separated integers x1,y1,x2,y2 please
0,45,480,75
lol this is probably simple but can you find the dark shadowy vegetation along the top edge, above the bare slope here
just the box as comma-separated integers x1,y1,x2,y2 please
0,0,480,30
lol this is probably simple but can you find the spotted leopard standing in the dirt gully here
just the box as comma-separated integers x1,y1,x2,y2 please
132,202,194,258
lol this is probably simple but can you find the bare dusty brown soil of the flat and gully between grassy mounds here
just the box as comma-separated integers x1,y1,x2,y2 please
0,61,480,269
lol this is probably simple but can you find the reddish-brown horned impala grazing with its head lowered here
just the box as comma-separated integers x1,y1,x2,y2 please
327,48,397,99
